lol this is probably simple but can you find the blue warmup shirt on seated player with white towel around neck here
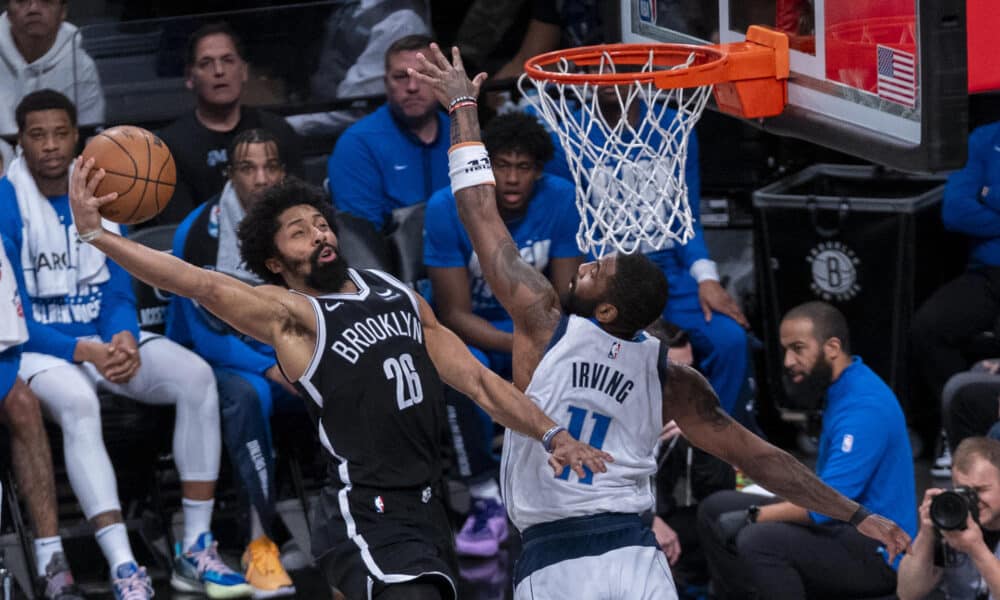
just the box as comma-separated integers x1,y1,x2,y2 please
0,178,139,362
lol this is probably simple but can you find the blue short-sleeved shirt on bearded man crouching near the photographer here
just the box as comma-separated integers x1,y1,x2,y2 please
809,356,917,548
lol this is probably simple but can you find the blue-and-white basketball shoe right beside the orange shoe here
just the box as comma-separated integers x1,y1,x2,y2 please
170,531,253,600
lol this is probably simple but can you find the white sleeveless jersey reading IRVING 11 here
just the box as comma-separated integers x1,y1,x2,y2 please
500,316,666,531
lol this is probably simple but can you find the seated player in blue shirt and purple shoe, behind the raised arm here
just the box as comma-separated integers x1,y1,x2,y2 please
424,113,583,556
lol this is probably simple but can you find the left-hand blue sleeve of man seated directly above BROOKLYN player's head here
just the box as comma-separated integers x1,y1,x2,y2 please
326,129,387,231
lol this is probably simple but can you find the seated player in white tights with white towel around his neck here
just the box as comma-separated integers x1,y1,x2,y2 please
0,90,252,600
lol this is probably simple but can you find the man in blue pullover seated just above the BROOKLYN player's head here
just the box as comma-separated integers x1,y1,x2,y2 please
327,35,451,231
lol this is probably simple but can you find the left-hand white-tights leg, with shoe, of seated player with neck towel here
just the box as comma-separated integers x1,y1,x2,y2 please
21,353,152,598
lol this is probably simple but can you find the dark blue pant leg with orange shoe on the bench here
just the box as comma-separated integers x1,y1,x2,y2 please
215,369,295,597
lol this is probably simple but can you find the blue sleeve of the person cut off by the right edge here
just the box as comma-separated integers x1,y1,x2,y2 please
941,128,1000,238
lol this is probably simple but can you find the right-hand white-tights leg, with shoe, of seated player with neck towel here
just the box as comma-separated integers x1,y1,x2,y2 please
100,332,253,598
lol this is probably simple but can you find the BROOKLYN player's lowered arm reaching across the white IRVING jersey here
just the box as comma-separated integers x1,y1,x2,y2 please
418,297,613,477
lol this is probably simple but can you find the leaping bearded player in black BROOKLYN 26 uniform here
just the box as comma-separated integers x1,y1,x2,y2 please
70,165,611,600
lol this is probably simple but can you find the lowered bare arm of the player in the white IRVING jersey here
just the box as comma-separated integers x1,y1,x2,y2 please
663,363,910,561
